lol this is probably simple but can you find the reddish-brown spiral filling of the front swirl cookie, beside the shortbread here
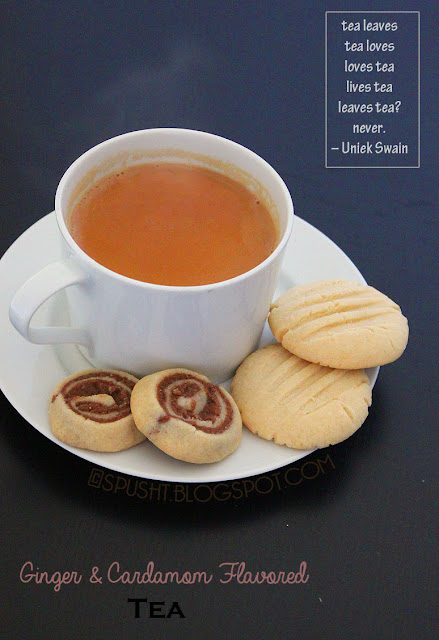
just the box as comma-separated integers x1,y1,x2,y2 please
157,373,233,433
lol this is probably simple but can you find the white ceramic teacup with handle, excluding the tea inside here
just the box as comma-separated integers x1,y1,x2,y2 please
10,129,293,382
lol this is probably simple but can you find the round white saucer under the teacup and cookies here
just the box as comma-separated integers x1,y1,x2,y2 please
0,213,378,482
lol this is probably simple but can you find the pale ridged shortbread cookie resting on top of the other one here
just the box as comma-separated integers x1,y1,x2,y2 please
268,280,409,369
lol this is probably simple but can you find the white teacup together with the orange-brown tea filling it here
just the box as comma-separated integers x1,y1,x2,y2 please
10,129,293,382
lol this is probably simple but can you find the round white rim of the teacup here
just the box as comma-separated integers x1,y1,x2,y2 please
55,127,294,293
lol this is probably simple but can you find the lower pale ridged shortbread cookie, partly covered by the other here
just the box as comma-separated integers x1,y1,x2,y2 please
231,344,372,449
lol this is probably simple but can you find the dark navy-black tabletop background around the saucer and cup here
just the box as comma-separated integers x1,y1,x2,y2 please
0,0,439,640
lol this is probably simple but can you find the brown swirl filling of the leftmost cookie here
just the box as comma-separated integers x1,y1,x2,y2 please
52,371,135,422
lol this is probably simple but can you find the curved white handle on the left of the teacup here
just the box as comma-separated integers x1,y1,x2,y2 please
9,258,91,347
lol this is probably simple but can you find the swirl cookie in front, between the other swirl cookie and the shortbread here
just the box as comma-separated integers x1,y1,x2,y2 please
131,369,242,463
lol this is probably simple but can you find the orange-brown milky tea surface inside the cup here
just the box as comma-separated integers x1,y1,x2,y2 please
69,162,278,286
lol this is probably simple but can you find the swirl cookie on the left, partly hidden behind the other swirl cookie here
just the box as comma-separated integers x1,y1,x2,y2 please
49,369,145,452
